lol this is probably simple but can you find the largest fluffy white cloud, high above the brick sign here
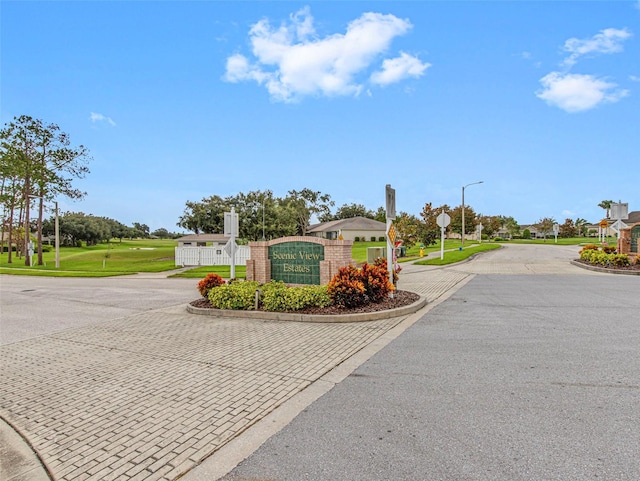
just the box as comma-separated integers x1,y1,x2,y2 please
223,7,429,102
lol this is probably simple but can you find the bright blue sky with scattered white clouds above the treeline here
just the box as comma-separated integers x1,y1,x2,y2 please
0,0,640,231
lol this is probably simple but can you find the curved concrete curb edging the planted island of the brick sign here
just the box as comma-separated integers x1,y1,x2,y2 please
187,296,427,322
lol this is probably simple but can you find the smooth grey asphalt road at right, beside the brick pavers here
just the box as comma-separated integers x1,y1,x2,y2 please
222,255,640,481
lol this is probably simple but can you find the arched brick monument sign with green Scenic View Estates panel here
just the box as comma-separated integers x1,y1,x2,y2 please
247,236,355,285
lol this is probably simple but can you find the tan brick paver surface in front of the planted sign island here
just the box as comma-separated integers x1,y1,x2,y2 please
0,266,471,481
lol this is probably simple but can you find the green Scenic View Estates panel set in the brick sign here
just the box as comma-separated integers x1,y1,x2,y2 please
269,242,324,285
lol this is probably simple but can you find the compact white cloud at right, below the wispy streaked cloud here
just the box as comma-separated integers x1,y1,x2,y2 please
536,72,629,113
